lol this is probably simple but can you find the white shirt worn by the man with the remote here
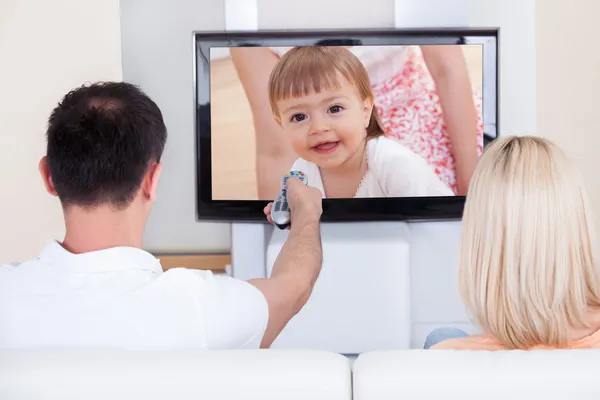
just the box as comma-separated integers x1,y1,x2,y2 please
0,241,269,349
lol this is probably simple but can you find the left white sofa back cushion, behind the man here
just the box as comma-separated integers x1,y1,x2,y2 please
0,350,352,400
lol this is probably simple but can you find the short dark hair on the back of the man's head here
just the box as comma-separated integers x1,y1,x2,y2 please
47,82,167,209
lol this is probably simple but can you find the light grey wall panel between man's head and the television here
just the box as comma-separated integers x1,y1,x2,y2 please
121,0,230,251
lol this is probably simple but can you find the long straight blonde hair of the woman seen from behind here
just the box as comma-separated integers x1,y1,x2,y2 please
458,136,600,349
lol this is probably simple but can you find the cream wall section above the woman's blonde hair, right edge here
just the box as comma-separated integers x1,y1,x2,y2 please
536,0,600,238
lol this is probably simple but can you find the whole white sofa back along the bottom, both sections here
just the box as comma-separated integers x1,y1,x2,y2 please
0,350,600,400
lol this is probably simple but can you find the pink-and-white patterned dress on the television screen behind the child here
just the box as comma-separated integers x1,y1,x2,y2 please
373,49,483,193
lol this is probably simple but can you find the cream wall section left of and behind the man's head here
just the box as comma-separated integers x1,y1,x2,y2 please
0,0,121,264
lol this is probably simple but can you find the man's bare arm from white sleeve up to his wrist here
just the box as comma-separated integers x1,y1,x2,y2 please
248,218,323,348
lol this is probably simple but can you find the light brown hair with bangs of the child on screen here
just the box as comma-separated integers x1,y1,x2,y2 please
269,46,383,138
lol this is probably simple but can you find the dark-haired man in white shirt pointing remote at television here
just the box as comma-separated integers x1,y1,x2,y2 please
0,82,322,349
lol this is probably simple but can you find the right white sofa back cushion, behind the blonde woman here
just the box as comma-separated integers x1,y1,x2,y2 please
353,350,600,400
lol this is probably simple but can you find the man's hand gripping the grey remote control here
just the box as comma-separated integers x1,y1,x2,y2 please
263,178,323,228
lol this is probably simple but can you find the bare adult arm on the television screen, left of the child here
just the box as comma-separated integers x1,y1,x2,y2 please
230,47,296,200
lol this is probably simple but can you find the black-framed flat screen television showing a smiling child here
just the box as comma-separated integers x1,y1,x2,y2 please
193,28,499,222
